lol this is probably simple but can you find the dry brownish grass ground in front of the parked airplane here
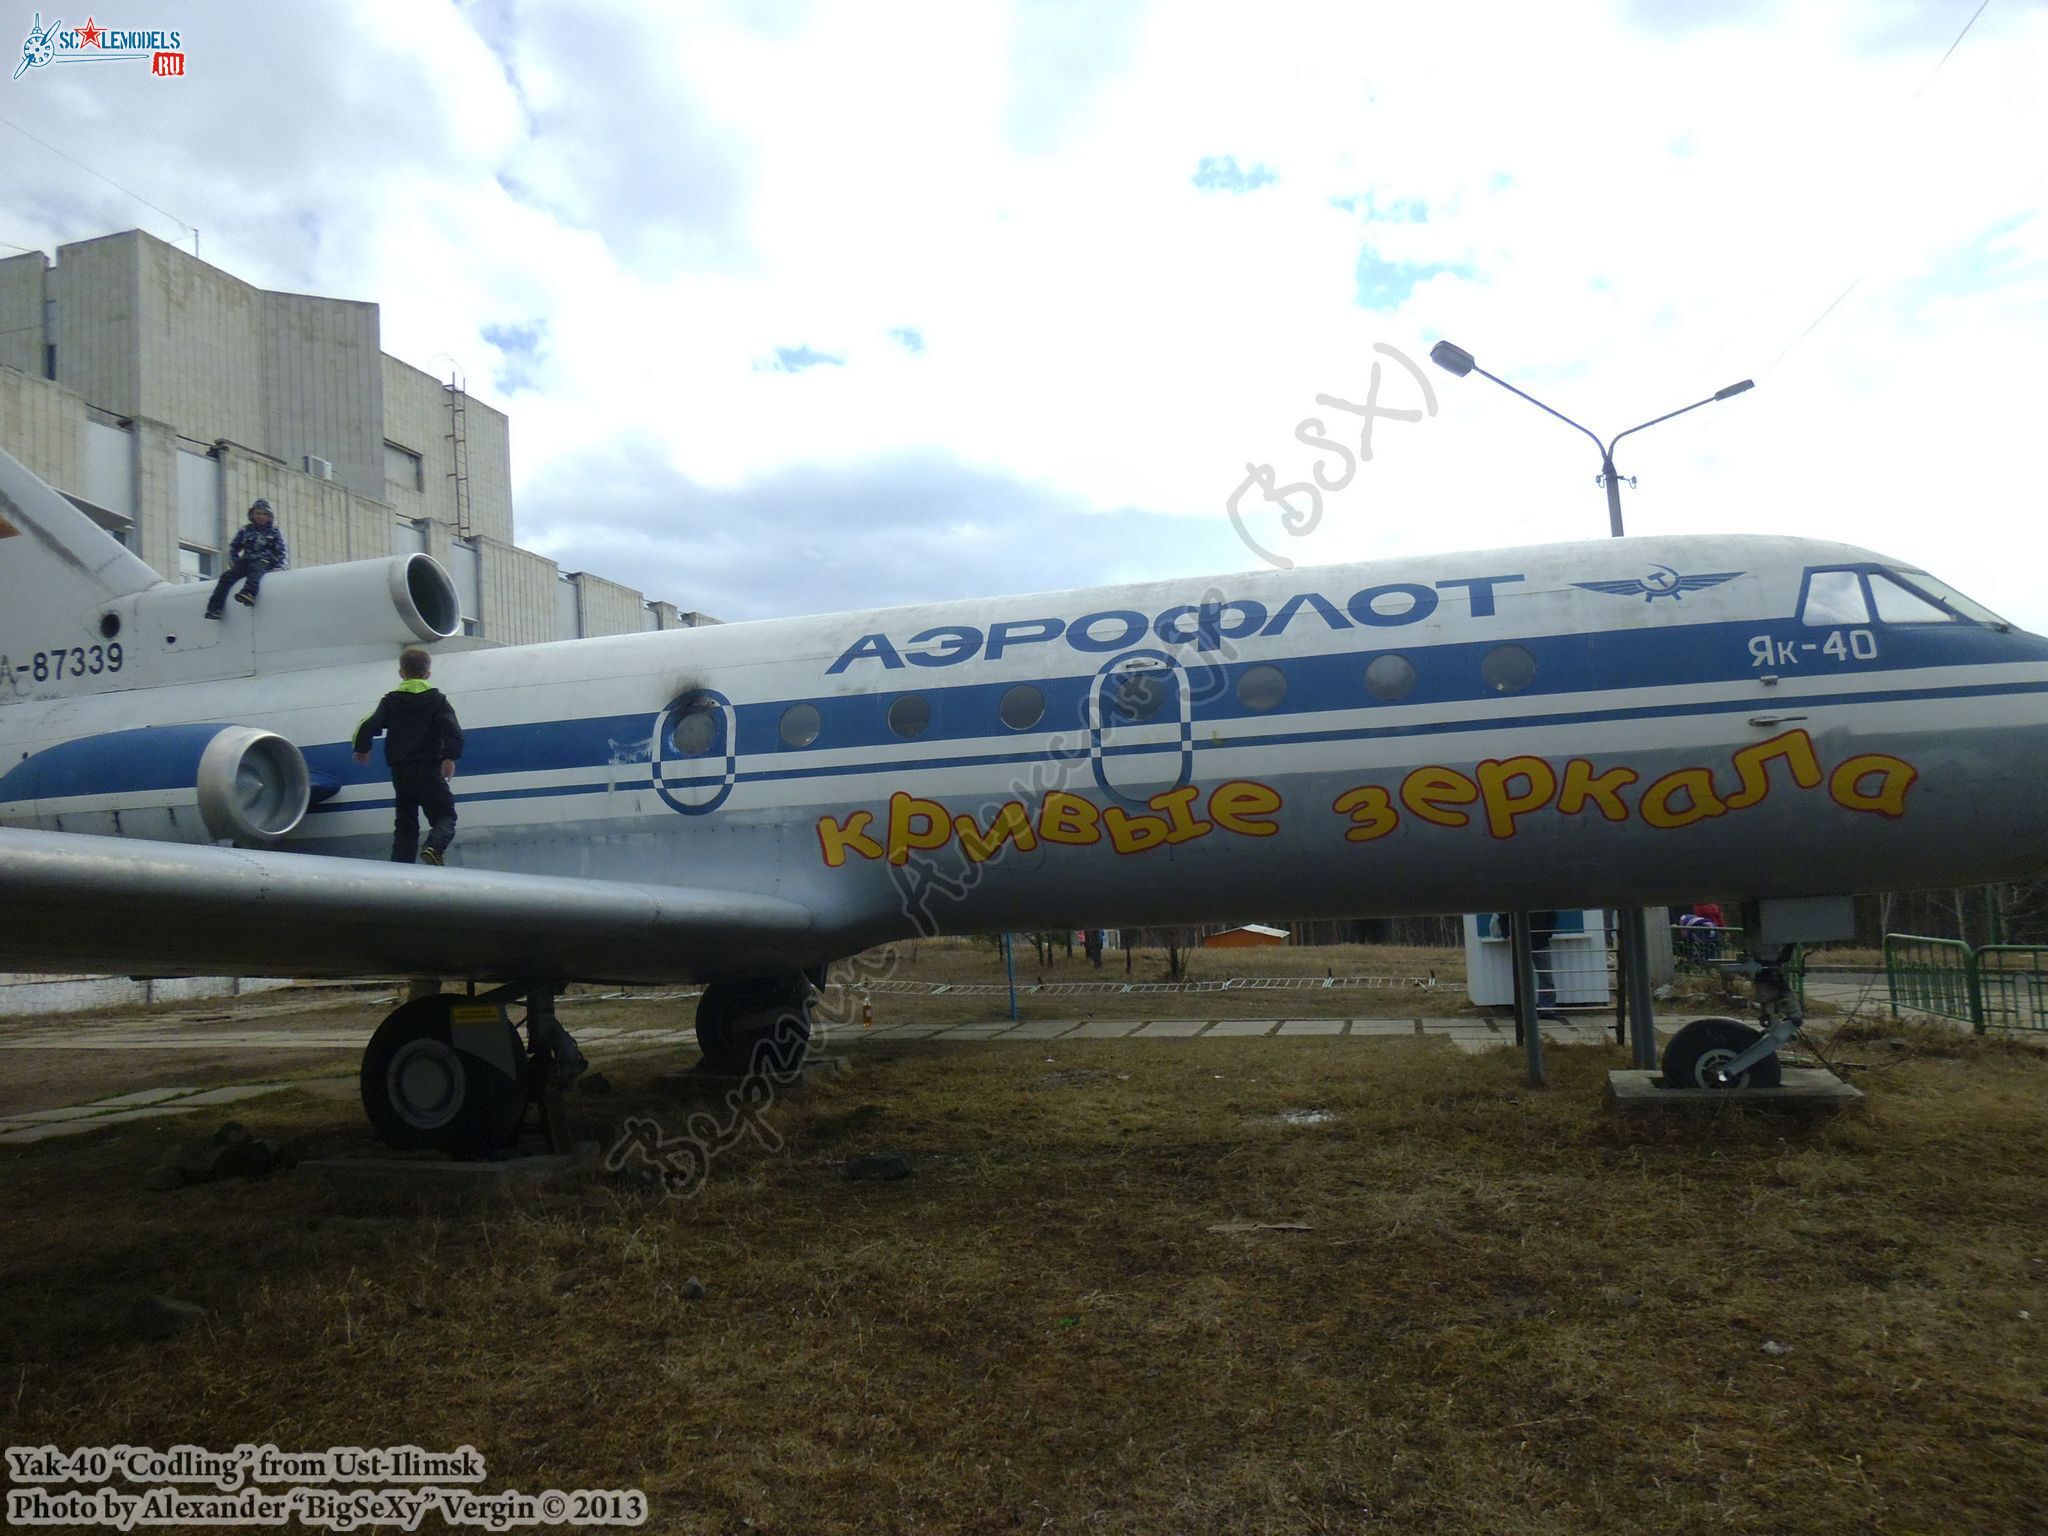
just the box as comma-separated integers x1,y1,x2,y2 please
0,1026,2048,1536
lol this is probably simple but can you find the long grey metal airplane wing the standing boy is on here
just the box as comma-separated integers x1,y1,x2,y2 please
0,827,815,981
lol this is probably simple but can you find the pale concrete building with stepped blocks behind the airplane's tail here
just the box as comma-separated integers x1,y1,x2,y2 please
0,229,715,645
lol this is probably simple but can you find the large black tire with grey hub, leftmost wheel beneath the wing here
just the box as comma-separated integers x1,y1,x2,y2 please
358,995,526,1155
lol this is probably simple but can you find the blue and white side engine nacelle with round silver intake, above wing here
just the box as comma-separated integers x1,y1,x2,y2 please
0,725,313,844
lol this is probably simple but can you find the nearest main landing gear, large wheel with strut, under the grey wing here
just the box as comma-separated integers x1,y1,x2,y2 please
358,981,588,1157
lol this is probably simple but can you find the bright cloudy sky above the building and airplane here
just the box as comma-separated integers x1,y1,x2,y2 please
0,0,2048,631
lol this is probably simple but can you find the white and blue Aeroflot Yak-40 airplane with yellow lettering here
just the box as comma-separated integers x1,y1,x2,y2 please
0,444,2048,1149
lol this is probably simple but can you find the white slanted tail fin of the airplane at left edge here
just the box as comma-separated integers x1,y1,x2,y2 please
0,451,164,705
